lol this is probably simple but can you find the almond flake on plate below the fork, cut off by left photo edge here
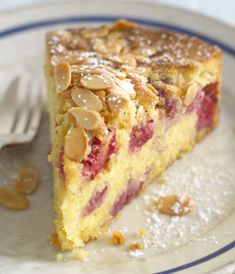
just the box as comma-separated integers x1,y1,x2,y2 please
0,187,30,210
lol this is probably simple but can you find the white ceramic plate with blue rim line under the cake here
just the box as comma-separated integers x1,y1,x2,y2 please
0,0,235,274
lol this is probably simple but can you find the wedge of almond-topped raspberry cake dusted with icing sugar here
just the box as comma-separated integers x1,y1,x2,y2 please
46,20,222,249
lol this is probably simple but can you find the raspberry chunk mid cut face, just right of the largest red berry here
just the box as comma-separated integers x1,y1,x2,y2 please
129,119,154,152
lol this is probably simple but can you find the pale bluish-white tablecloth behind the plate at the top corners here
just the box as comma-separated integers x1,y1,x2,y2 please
0,0,235,26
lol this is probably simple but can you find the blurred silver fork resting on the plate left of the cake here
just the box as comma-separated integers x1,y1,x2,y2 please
0,76,43,149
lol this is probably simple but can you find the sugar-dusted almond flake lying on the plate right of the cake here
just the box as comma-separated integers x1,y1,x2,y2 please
156,195,193,216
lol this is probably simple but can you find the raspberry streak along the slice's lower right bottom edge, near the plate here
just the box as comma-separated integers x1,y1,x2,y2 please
111,181,144,216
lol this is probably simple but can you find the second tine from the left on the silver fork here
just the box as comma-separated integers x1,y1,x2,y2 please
12,76,33,134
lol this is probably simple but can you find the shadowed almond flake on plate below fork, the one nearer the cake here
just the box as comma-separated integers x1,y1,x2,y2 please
13,165,38,194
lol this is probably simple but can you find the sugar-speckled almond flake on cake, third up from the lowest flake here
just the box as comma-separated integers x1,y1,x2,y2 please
71,87,103,112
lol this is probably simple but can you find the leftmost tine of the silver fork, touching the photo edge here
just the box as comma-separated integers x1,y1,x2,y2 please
0,76,20,134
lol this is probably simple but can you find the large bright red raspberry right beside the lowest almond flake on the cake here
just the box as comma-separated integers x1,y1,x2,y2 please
82,134,118,180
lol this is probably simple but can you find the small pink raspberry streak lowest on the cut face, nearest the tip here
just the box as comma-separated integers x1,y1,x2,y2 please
82,186,108,217
